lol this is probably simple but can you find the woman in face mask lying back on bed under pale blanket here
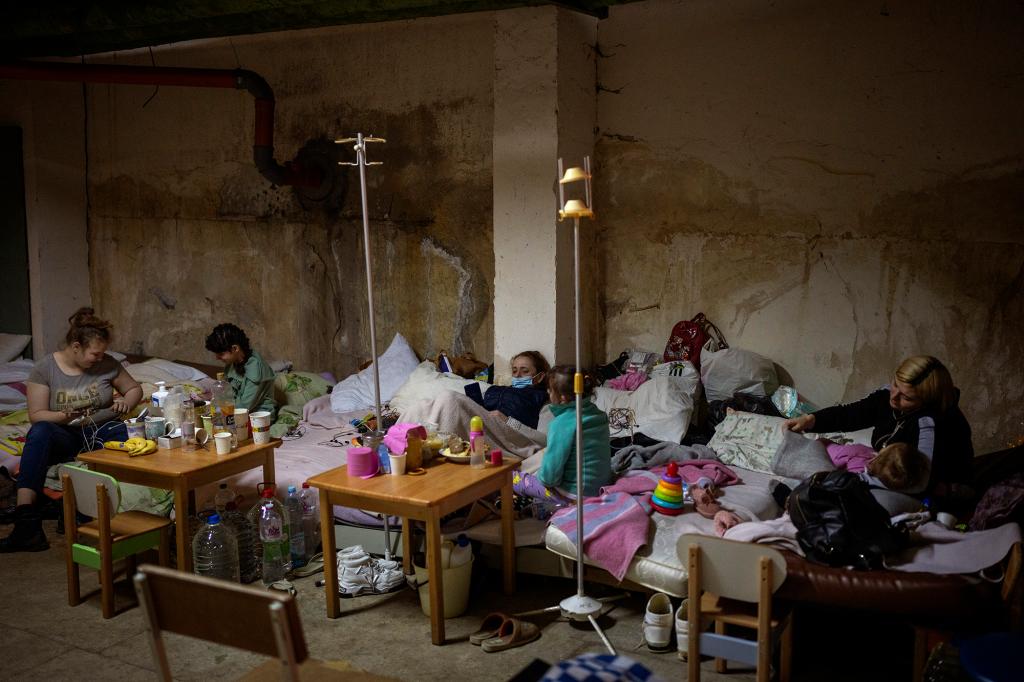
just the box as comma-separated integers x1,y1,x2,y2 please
401,350,549,459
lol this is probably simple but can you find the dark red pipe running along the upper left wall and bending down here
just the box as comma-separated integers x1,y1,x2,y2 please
0,61,324,187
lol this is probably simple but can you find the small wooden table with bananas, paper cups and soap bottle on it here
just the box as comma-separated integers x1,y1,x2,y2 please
78,438,281,571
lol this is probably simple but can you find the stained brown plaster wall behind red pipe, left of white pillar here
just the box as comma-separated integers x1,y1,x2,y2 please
87,14,494,376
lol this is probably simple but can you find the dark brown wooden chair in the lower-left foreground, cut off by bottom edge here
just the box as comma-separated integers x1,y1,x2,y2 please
135,565,390,682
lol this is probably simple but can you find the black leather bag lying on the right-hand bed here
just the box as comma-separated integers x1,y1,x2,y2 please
787,471,907,570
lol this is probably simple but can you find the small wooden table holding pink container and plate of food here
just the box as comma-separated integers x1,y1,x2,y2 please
309,462,519,644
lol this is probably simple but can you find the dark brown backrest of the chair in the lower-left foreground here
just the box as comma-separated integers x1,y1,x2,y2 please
135,564,309,664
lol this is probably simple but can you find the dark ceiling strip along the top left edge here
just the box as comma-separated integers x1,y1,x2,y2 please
0,0,631,58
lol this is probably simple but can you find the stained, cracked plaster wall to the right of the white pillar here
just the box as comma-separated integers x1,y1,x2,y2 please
596,0,1024,452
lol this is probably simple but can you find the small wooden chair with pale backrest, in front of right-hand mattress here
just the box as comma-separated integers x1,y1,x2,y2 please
676,535,793,682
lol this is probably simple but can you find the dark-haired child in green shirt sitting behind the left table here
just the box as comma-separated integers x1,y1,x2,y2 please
206,323,278,419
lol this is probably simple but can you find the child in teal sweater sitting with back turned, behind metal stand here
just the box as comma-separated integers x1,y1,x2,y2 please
513,365,611,504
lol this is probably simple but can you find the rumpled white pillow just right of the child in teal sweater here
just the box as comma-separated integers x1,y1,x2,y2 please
594,363,700,442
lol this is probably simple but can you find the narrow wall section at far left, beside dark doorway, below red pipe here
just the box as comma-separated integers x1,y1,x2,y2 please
0,81,90,357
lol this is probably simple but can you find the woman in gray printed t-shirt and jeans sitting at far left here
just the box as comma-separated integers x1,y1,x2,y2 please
0,308,142,553
